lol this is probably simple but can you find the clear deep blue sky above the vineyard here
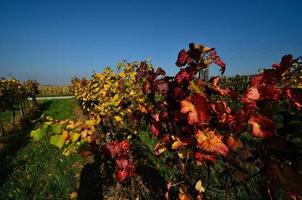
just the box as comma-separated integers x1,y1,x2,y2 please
0,0,302,84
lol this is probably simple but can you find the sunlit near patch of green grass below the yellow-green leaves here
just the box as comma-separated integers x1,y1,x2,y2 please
0,140,83,200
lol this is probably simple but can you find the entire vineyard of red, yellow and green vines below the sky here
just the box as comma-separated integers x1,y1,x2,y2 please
0,43,302,200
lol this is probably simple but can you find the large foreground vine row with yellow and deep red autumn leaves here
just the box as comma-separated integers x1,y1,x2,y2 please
31,43,302,199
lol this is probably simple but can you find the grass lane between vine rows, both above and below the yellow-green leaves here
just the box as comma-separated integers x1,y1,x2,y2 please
0,99,84,200
